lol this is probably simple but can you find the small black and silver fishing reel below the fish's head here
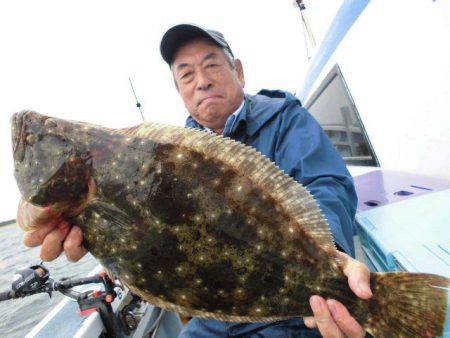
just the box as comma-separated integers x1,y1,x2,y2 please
12,263,50,297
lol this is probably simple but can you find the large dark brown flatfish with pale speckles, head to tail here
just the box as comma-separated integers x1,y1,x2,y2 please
12,111,449,337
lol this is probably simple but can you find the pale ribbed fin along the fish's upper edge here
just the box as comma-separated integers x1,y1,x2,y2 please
122,123,335,253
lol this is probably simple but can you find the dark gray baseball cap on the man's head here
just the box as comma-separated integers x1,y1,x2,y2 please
159,24,233,65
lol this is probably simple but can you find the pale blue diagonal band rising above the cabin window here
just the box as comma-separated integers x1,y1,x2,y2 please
298,0,370,102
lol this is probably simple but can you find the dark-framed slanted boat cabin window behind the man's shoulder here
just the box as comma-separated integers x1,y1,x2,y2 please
305,64,380,167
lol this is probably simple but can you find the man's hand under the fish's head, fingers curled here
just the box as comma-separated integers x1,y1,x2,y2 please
17,200,87,262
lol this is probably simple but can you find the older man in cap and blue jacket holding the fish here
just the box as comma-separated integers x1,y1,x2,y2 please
18,25,372,338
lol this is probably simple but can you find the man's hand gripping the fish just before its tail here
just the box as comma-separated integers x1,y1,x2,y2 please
303,252,372,338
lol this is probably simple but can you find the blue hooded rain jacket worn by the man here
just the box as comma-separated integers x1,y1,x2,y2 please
186,90,357,256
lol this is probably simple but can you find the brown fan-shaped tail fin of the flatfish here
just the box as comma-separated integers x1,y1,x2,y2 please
364,272,450,337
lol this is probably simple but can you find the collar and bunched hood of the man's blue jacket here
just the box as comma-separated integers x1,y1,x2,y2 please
186,89,298,136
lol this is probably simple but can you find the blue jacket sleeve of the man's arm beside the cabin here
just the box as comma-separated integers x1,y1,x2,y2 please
275,101,357,257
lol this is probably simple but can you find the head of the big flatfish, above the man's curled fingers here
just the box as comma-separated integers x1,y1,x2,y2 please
11,111,90,206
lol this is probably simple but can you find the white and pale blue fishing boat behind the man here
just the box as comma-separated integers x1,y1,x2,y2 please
3,0,450,338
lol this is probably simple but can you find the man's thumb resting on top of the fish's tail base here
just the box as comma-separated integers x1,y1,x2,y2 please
338,252,373,299
